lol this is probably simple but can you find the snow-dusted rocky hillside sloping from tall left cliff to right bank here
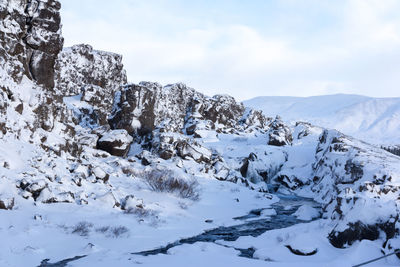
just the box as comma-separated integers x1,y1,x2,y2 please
0,0,400,266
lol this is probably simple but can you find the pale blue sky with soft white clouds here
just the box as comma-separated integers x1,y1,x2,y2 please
61,0,400,100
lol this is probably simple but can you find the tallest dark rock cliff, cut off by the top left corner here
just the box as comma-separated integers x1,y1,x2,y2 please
0,0,64,89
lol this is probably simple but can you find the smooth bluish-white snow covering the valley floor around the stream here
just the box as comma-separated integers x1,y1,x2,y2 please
0,122,400,266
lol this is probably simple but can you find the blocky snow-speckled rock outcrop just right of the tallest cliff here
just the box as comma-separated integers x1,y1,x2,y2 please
55,44,127,127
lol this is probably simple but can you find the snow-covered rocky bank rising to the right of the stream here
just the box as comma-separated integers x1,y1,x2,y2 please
304,130,400,247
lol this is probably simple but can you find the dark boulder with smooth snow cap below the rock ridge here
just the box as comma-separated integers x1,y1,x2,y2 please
97,130,133,157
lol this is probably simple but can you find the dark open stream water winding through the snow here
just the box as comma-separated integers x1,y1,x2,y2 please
132,195,321,258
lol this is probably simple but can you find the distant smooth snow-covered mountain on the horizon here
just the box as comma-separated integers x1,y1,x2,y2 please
243,94,400,144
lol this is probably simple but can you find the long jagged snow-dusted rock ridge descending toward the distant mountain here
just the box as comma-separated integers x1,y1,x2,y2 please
109,82,268,136
